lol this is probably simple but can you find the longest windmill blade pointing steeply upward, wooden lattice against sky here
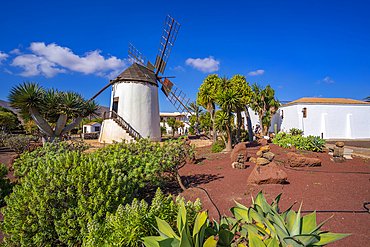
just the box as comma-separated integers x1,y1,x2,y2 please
154,15,180,76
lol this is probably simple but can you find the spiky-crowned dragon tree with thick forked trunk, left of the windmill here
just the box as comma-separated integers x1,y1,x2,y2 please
8,82,100,141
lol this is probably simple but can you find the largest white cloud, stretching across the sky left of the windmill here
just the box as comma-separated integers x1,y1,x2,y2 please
11,42,127,79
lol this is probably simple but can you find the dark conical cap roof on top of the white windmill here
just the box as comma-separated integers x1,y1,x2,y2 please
114,63,158,87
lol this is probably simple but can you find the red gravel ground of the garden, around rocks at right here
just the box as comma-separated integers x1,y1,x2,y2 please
180,144,370,246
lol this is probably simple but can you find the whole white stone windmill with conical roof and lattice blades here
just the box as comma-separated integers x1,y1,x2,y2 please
97,15,192,143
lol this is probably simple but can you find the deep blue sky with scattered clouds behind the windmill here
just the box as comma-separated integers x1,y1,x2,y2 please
0,0,370,112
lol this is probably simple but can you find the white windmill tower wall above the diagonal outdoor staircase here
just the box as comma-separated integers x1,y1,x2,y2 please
106,83,161,141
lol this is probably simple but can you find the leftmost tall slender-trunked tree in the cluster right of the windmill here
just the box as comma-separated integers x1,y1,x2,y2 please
197,74,221,144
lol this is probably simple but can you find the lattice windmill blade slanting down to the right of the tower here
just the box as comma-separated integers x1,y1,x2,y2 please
159,78,193,115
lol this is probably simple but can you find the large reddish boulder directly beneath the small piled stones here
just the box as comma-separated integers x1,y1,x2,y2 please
247,163,288,184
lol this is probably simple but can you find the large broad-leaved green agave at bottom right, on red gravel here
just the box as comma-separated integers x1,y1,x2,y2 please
230,191,350,247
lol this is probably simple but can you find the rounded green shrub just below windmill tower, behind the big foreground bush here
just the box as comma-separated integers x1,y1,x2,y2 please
96,138,194,189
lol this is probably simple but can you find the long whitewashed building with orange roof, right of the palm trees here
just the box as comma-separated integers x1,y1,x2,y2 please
242,98,370,139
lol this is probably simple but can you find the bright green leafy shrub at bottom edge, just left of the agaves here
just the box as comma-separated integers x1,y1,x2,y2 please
83,188,202,246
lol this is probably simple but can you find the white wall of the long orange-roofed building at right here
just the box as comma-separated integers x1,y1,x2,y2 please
279,103,370,139
